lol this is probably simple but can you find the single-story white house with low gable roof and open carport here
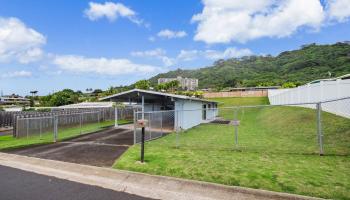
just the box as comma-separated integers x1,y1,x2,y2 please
100,89,217,129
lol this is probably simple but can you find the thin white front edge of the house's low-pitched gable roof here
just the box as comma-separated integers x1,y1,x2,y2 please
99,89,217,103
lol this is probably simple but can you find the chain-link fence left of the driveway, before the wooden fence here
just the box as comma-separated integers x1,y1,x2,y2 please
13,108,133,141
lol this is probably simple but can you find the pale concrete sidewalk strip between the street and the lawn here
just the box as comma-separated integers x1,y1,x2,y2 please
0,153,322,200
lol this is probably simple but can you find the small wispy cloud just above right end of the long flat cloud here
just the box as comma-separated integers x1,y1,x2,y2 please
131,48,174,67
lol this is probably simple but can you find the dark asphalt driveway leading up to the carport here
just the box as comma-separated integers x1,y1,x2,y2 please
8,128,134,167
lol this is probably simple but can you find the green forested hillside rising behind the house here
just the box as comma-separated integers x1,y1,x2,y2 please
150,42,350,88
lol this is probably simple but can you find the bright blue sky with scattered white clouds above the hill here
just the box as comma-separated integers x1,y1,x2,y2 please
0,0,350,95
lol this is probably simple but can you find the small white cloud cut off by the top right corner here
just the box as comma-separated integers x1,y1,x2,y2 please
328,0,350,22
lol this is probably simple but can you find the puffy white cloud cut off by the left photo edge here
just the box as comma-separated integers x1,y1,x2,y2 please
0,17,46,63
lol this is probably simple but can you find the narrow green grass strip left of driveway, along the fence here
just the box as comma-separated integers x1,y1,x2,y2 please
0,120,129,150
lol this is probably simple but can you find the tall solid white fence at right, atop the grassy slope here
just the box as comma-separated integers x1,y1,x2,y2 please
268,79,350,118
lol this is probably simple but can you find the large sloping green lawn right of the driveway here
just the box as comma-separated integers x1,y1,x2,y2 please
114,98,350,199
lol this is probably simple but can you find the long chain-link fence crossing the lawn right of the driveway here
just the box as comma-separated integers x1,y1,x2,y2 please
134,97,350,157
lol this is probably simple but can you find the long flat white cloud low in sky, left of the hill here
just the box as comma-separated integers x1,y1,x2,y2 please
53,55,159,75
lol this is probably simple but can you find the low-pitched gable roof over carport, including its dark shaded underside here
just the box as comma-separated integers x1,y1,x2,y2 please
100,89,217,103
